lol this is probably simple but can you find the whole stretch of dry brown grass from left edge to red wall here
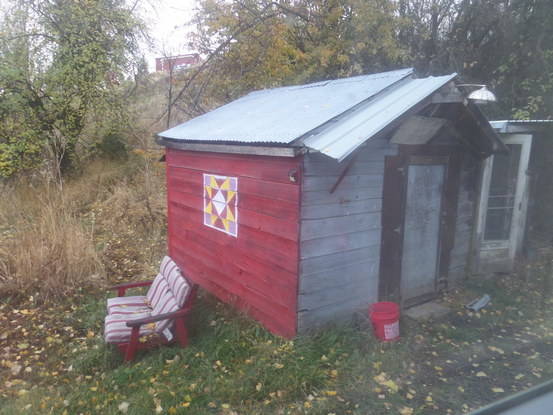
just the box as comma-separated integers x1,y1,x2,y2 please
0,152,167,300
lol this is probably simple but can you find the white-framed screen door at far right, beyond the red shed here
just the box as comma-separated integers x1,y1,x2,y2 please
478,134,532,273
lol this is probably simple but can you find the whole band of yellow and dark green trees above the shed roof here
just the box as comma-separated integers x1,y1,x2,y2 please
165,0,553,123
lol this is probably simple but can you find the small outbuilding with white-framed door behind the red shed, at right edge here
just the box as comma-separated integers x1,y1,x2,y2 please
473,120,553,274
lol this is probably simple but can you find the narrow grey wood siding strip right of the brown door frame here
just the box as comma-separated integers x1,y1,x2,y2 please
448,151,479,283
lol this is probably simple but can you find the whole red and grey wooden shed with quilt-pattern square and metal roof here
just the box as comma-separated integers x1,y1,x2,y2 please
158,69,505,337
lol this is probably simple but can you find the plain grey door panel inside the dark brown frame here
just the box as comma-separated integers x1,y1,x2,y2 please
401,164,445,306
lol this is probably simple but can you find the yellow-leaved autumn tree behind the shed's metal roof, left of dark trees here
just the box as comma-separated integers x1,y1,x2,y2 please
162,0,404,122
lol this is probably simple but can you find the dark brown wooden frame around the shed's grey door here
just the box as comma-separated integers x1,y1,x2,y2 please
379,145,464,304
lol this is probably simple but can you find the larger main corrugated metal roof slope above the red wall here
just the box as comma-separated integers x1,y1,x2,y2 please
159,69,413,144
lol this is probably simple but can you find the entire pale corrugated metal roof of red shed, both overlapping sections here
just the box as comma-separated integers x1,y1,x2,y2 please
158,68,456,160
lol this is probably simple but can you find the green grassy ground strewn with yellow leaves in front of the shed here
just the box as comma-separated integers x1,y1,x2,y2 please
0,275,553,414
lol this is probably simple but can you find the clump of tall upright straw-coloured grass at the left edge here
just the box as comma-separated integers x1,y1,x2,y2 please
0,185,105,301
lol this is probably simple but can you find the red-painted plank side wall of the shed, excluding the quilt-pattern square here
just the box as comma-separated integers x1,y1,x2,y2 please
166,148,300,337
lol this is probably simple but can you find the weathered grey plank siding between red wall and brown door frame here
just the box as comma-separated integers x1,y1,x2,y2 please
298,139,396,333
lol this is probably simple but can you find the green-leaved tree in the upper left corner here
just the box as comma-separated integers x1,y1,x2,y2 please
0,0,144,176
